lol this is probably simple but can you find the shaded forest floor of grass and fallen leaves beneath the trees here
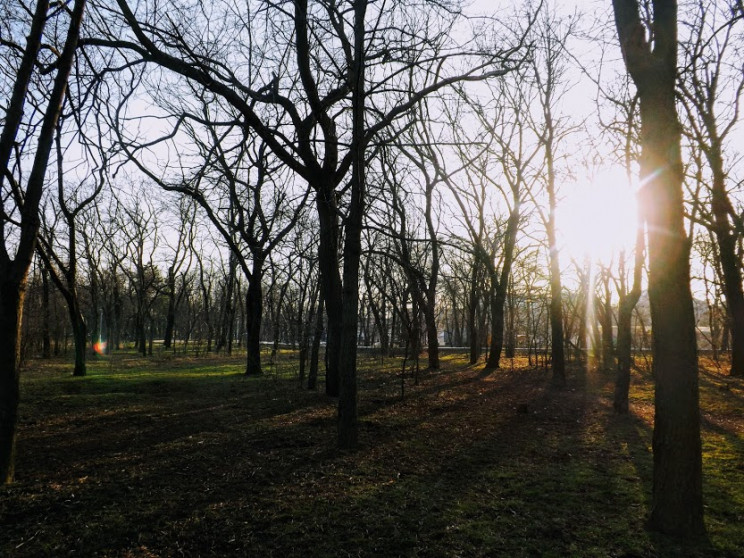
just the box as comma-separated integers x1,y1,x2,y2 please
0,355,744,557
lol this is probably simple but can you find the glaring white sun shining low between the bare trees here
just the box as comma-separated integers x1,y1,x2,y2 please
556,169,638,264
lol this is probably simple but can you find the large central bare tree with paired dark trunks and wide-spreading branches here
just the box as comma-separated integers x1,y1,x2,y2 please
85,0,522,446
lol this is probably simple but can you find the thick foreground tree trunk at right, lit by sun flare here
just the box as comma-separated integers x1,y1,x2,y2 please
613,0,705,538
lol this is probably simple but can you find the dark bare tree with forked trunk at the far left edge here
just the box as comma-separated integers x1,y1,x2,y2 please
0,0,85,483
